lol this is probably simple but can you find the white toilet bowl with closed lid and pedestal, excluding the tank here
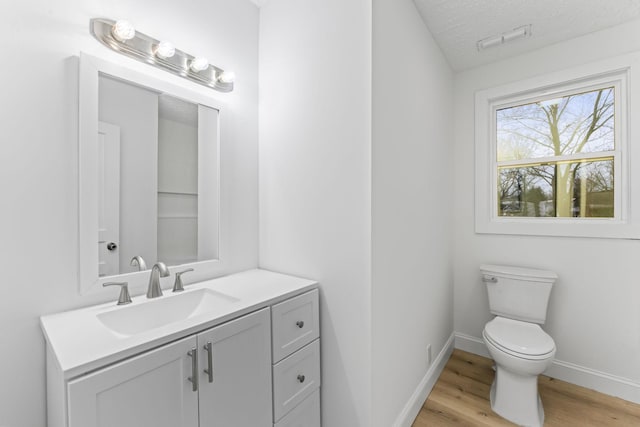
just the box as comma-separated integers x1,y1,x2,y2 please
482,317,556,427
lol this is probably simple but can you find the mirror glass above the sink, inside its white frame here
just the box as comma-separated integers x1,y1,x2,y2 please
96,74,218,277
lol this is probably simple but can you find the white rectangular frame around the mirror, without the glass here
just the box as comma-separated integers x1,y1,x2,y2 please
78,52,223,295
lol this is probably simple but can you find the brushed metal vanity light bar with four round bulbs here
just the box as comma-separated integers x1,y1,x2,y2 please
90,18,235,92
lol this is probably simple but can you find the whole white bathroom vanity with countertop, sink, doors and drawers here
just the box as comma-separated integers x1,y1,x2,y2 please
41,269,320,427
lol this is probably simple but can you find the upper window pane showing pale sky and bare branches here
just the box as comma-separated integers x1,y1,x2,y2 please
496,87,615,161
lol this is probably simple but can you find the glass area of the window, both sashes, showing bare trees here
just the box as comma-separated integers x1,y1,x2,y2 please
496,87,615,218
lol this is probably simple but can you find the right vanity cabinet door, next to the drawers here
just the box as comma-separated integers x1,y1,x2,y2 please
198,308,271,427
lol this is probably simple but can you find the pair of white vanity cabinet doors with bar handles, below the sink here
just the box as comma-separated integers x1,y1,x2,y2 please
68,308,271,427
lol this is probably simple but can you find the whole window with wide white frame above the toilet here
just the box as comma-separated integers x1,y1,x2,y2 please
475,57,640,238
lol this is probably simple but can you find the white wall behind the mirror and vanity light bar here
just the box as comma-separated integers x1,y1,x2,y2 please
0,0,258,427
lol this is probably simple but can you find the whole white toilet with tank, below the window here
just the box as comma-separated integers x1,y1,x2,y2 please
480,265,558,427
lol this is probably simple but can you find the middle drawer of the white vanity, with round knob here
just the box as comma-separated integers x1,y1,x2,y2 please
273,340,320,421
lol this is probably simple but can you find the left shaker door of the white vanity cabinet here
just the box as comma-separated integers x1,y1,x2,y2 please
67,337,198,427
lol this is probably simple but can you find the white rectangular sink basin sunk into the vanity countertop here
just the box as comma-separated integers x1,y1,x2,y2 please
97,289,240,335
